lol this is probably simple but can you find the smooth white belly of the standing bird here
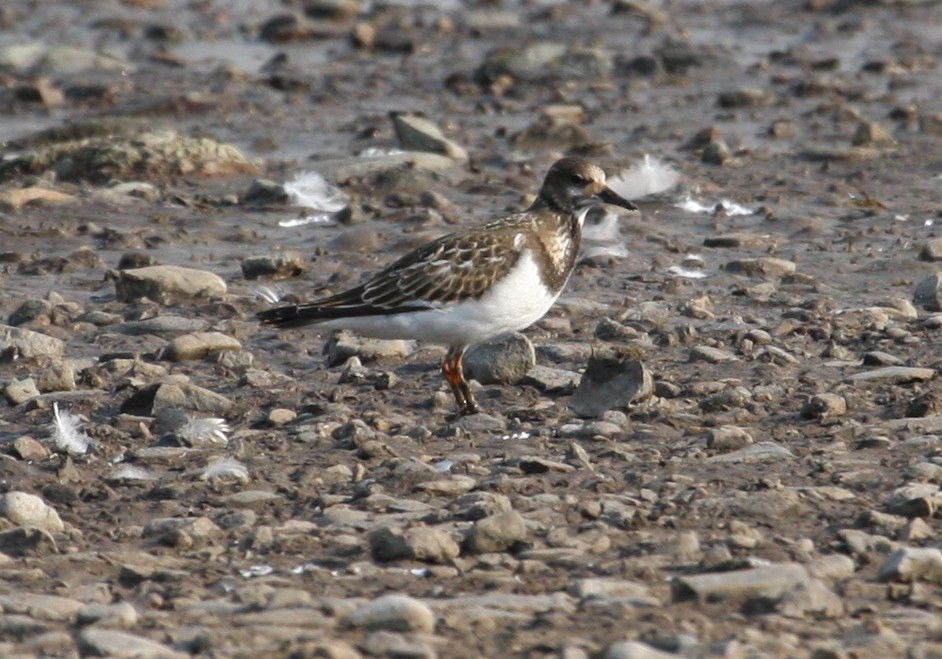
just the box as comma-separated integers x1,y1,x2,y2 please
320,251,559,345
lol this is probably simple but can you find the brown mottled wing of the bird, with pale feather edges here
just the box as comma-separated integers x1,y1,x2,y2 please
259,216,523,326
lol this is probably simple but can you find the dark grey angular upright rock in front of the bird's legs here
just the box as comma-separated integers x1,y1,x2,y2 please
569,348,654,418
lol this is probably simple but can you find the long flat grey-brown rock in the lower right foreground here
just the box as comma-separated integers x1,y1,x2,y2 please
671,563,809,602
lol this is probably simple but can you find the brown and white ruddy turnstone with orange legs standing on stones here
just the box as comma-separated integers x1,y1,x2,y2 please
258,158,636,415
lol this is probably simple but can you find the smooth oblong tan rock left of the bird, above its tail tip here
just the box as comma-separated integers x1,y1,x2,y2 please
115,265,226,303
